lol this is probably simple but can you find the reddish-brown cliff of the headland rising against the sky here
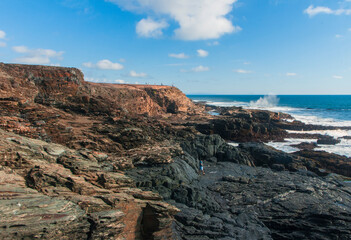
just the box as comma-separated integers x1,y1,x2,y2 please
0,63,198,115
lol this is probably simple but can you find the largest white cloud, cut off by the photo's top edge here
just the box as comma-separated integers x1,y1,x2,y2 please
105,0,241,40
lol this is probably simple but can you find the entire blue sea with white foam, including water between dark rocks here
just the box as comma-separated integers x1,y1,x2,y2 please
188,95,351,157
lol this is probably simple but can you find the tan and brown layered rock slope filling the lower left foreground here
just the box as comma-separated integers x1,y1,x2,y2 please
0,130,178,239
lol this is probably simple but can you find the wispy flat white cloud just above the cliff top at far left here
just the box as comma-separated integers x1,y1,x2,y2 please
12,46,64,64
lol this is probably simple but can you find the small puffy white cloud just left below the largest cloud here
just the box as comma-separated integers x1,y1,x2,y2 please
136,18,169,38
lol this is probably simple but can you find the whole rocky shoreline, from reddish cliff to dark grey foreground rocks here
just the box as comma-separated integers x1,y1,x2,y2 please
0,63,351,240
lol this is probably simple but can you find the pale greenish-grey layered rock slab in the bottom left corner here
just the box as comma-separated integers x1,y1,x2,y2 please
0,184,90,239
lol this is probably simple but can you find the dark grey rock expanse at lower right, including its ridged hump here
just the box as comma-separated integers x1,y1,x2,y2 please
127,136,351,239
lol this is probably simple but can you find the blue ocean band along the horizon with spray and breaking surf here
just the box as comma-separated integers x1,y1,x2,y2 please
188,95,351,126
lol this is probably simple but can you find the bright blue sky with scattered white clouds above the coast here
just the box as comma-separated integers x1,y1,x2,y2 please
0,0,351,95
